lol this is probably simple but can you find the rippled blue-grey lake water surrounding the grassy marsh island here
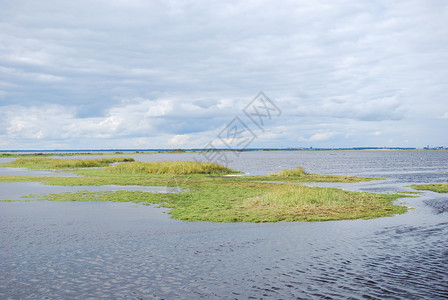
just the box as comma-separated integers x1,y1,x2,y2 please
0,151,448,299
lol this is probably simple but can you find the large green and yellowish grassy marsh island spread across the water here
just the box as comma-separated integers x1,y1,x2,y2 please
0,157,407,222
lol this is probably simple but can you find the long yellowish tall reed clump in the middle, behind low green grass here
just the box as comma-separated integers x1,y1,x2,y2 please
105,161,238,175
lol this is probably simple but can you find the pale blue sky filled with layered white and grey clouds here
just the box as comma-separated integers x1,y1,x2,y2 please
0,0,448,150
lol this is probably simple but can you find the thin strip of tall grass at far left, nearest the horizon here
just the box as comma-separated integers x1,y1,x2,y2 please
2,157,134,169
